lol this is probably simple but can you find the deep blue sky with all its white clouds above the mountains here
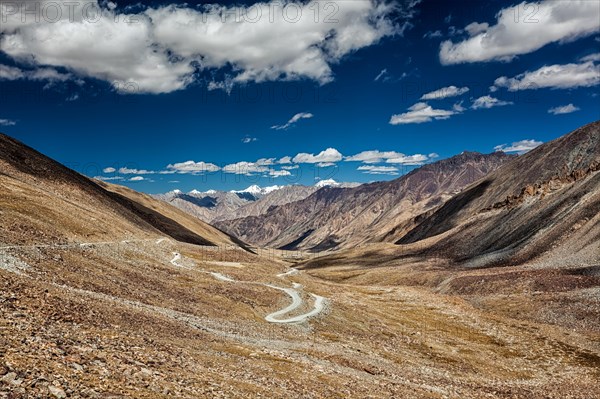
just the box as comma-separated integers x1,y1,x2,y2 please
0,0,600,193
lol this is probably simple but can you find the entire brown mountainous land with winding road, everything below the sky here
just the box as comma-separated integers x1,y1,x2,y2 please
0,122,600,399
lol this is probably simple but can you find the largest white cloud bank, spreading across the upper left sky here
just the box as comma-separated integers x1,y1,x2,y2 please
0,0,418,93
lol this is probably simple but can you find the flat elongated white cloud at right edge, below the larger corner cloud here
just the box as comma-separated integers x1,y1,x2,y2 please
494,61,600,91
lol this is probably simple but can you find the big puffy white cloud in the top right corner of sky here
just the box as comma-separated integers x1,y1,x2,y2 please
440,0,600,65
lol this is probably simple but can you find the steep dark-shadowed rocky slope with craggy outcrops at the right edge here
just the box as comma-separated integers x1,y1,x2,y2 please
398,122,600,266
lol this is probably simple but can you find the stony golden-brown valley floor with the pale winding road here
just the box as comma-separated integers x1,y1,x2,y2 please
0,237,600,399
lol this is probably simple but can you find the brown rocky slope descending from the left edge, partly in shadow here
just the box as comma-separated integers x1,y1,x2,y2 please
0,134,237,245
